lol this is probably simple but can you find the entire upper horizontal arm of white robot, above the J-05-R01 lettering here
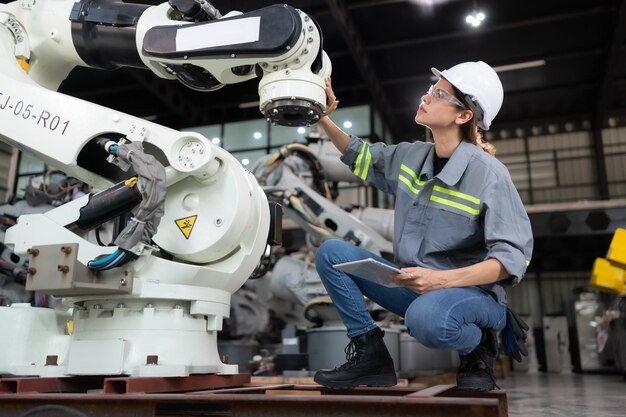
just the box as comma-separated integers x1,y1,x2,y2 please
0,0,331,126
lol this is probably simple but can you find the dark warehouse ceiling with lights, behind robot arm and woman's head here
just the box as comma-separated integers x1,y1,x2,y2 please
24,0,626,141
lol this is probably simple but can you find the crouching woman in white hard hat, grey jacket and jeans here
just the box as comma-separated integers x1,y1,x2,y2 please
315,62,532,391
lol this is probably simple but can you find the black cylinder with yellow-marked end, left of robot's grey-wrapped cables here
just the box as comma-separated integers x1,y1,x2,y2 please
76,180,142,230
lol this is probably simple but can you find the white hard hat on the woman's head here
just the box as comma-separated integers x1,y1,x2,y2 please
431,61,504,130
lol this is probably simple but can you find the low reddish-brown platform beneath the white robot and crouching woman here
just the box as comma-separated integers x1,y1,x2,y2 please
0,375,508,417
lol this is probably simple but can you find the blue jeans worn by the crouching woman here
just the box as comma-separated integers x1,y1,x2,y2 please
315,240,506,355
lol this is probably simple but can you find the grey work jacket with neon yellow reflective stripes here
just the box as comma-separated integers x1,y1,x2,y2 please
341,136,533,304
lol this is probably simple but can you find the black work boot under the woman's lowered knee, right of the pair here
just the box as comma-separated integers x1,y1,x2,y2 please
456,330,500,391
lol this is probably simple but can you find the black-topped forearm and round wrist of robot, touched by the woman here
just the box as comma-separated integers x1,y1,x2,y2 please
137,4,331,126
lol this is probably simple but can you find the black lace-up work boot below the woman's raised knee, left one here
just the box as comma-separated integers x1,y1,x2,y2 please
313,327,398,388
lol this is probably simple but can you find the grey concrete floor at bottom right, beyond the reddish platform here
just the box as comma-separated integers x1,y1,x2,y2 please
498,373,626,417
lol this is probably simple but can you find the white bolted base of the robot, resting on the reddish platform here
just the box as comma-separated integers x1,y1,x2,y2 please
0,300,238,377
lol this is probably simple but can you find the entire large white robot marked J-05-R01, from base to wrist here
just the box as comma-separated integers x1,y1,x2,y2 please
0,0,330,376
